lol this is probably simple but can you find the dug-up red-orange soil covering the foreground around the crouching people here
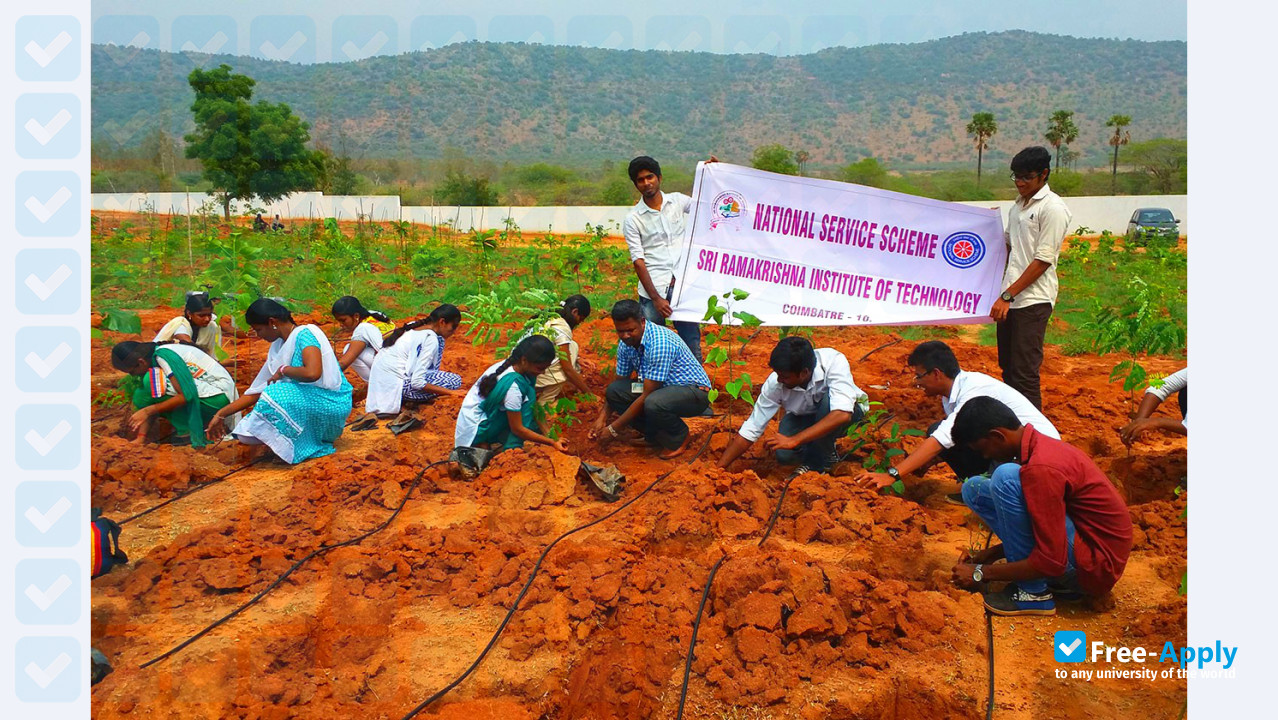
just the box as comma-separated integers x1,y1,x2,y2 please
93,311,1186,720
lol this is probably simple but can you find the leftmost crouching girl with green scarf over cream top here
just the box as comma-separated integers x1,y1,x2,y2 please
111,340,239,448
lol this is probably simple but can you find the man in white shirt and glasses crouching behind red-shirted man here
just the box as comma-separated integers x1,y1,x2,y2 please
856,340,1061,505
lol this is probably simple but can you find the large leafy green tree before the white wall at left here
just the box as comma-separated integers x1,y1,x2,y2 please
184,64,323,220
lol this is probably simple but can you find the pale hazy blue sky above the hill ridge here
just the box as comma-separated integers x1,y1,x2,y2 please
93,0,1187,63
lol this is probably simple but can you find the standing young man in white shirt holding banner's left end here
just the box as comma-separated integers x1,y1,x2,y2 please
621,155,713,362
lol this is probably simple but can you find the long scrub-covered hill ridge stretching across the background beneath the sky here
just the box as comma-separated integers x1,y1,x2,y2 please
92,32,1186,166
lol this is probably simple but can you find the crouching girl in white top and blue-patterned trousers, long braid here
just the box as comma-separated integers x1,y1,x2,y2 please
350,303,461,431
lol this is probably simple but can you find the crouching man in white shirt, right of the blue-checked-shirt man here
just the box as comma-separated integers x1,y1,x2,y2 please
718,336,869,472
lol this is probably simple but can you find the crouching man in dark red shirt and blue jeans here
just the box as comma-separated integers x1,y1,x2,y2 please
953,398,1131,615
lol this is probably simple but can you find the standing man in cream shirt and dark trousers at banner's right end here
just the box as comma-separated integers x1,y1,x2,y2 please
989,146,1071,409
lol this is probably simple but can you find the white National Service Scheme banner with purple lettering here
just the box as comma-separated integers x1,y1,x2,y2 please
671,162,1007,325
